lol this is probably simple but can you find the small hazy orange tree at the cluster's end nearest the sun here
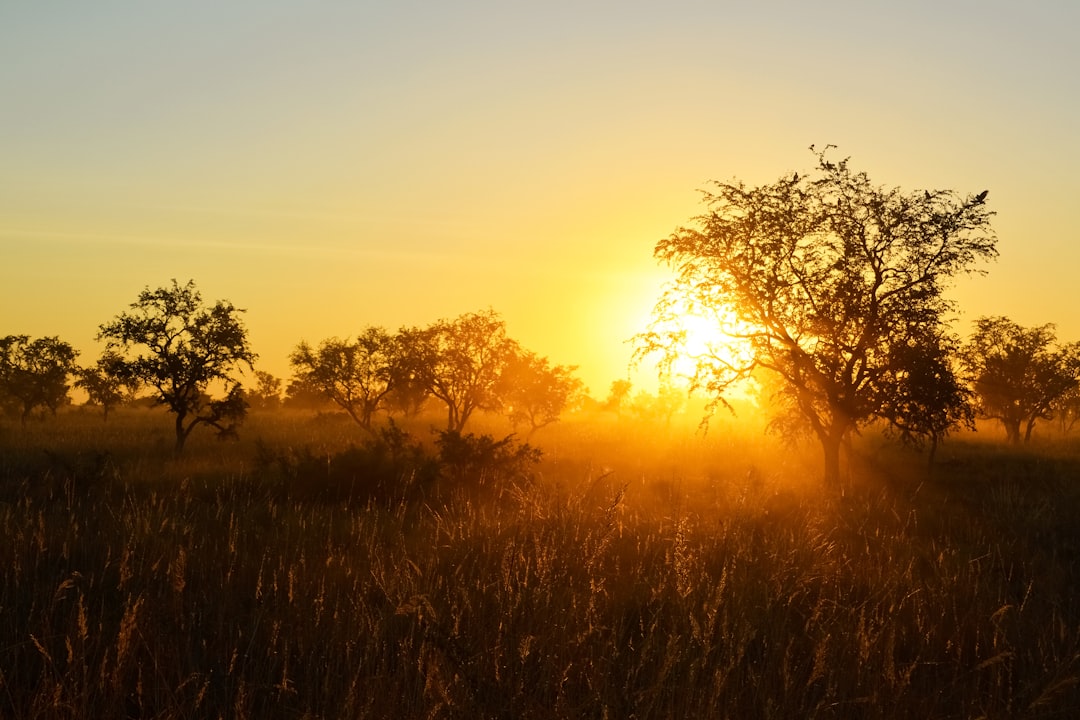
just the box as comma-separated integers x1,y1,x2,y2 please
500,350,584,437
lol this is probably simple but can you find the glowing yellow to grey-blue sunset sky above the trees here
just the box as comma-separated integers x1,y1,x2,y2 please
0,0,1080,397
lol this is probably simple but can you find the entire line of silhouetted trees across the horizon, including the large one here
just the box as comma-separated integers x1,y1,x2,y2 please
0,147,1080,481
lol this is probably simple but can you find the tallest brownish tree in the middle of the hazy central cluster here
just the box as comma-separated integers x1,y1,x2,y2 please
401,310,517,433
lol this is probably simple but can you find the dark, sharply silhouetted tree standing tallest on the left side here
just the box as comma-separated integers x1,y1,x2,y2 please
97,280,256,456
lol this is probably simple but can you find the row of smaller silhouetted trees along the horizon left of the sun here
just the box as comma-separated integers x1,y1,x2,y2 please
0,280,584,454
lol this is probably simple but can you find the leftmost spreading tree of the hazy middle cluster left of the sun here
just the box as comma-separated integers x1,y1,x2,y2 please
289,327,396,435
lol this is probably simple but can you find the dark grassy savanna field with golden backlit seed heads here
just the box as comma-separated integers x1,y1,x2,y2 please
0,409,1080,719
